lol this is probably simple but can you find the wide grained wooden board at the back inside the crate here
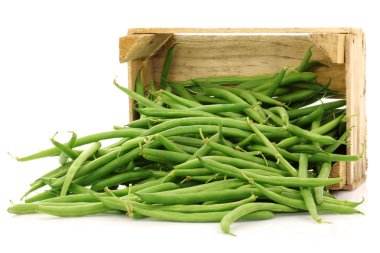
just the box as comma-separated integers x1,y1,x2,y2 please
153,35,345,93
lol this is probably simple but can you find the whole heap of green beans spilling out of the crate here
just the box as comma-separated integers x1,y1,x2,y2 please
8,47,361,233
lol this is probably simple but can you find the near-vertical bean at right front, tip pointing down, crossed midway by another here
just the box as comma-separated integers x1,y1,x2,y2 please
298,154,322,223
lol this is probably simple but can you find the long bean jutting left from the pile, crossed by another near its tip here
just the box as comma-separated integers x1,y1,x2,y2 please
17,128,144,162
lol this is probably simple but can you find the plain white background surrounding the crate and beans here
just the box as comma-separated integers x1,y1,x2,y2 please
0,0,380,252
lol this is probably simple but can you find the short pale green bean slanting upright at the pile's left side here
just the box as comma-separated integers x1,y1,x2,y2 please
61,142,101,196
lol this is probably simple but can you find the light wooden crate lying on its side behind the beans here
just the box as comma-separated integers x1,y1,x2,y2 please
120,28,367,190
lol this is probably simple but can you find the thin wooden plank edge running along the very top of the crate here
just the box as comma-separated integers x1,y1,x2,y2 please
128,27,361,34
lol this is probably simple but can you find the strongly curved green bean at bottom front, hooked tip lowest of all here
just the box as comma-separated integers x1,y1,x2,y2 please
220,203,297,235
